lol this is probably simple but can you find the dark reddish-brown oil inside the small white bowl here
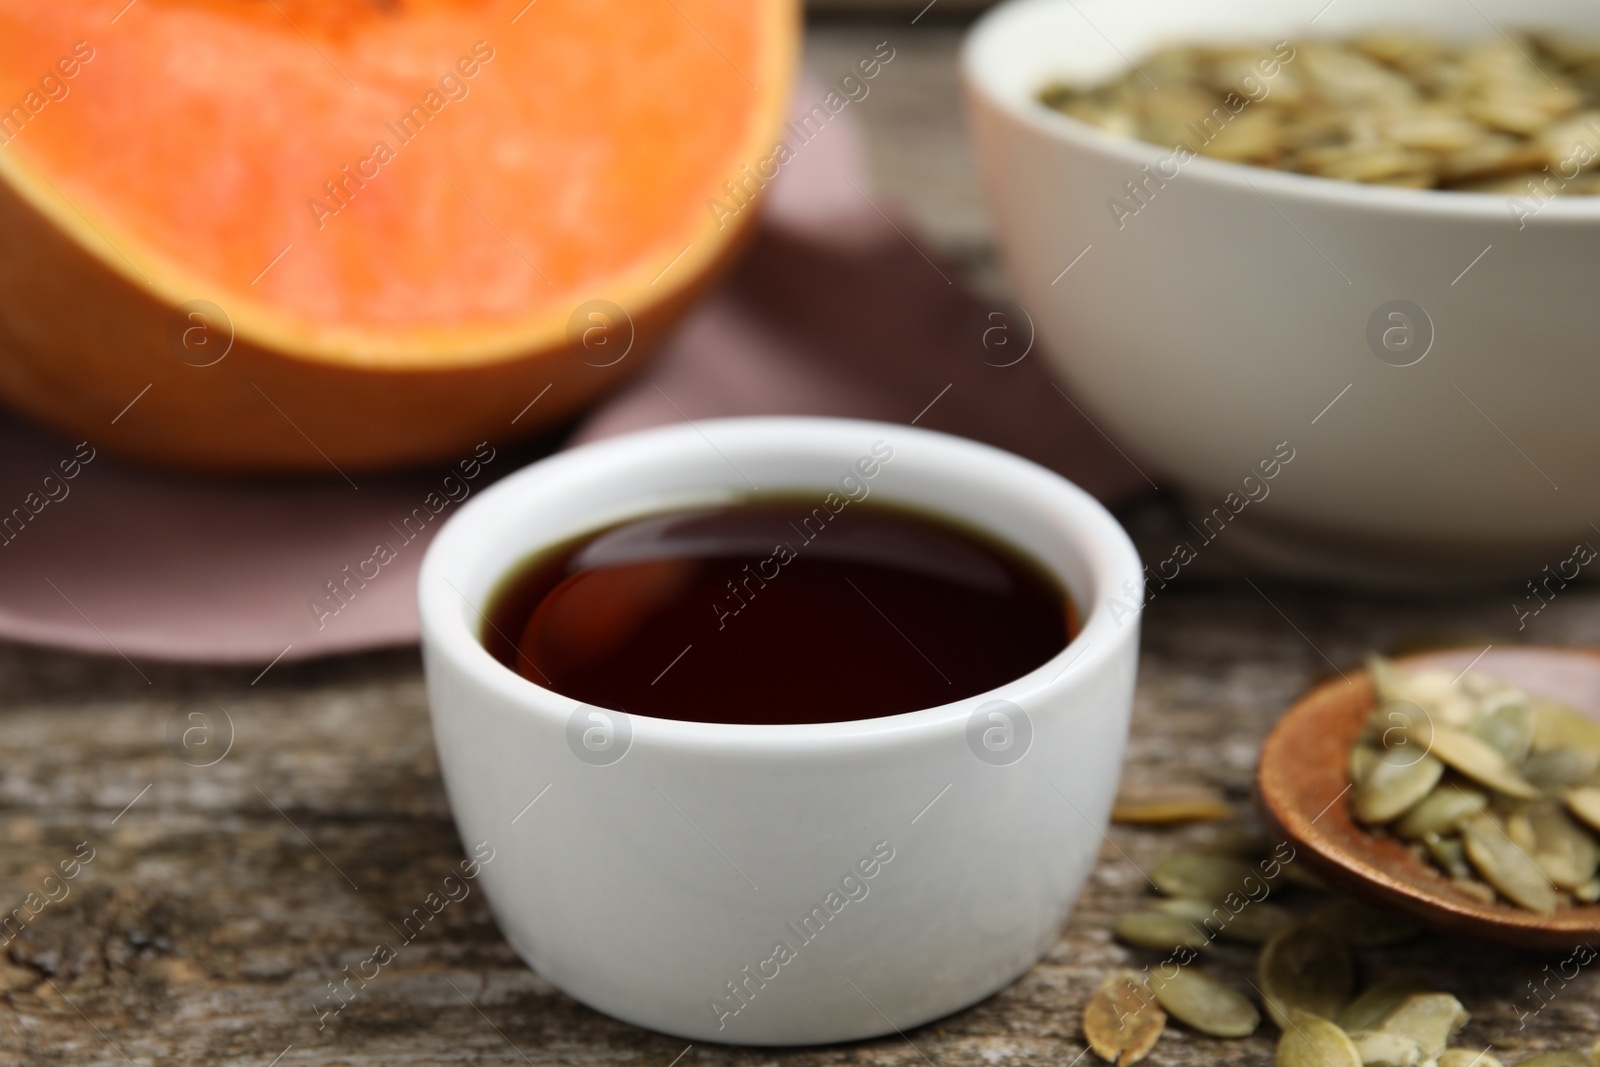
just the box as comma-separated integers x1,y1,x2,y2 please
483,496,1077,723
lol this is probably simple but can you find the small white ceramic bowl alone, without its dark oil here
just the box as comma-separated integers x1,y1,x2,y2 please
419,419,1141,1045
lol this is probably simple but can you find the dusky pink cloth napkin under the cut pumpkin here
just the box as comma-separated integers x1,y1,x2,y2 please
0,102,1149,665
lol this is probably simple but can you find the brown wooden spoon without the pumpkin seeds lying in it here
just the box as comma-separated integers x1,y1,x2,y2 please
1256,646,1600,949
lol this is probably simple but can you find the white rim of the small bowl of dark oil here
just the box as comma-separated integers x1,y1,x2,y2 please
418,416,1144,755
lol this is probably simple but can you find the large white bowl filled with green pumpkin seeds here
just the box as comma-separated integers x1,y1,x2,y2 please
963,0,1600,585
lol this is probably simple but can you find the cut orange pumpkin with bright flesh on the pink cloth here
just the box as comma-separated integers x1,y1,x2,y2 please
0,0,798,472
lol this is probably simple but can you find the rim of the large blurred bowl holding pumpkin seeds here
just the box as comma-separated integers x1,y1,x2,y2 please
960,0,1600,222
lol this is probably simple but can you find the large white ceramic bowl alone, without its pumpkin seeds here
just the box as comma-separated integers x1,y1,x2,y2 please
962,0,1600,582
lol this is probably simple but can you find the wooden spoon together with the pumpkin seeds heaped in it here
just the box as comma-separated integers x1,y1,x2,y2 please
1256,646,1600,949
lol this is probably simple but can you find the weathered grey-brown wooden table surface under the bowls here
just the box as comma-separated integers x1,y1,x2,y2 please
0,18,1600,1067
